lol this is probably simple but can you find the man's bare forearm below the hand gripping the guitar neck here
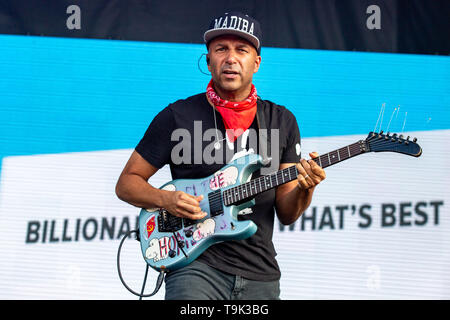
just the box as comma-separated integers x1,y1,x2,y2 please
276,187,315,225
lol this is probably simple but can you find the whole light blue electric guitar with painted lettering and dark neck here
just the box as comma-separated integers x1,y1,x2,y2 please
139,131,422,271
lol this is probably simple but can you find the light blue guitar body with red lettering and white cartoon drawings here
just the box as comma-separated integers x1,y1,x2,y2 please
139,154,263,271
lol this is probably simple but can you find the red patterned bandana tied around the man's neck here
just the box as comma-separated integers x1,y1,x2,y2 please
206,79,257,142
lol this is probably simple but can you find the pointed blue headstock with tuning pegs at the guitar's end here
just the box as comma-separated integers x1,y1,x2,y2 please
365,131,422,157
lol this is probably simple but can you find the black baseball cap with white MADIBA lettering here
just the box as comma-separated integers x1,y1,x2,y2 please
203,12,262,55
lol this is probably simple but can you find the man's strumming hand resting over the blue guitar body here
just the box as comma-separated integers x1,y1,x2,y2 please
163,191,206,220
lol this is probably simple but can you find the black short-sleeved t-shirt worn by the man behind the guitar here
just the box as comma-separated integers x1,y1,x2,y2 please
136,93,300,281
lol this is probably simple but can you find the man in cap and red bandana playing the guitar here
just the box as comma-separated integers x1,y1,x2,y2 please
116,12,325,299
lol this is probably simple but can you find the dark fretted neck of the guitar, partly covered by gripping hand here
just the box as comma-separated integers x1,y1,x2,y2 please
222,140,368,206
